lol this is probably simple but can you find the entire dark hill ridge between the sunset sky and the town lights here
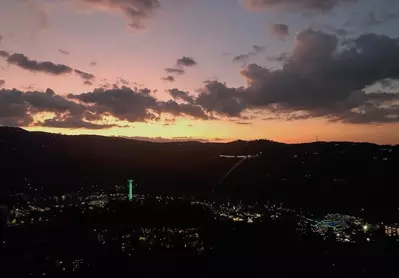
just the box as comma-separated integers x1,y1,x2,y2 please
0,127,399,218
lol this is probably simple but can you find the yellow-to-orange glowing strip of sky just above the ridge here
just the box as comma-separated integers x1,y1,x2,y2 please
25,117,399,144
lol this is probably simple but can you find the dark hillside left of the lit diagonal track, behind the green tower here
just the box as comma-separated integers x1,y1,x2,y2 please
0,127,271,194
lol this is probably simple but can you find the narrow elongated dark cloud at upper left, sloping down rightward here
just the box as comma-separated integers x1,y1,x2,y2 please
5,53,72,75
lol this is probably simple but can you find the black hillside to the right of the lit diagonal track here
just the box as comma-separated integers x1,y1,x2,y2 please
223,142,399,222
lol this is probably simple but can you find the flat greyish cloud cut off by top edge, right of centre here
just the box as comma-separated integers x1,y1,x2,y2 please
243,0,359,12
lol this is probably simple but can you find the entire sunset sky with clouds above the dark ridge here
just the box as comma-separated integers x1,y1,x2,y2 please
0,0,399,144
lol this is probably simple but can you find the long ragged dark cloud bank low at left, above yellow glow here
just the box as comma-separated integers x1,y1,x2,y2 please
0,86,208,129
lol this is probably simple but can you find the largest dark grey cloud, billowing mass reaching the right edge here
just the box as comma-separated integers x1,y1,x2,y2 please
190,29,399,123
